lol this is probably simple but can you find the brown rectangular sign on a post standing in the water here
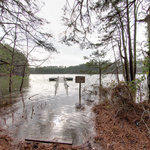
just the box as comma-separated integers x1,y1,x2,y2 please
75,76,85,107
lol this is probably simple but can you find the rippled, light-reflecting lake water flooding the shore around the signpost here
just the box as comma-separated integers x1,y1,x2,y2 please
0,75,148,145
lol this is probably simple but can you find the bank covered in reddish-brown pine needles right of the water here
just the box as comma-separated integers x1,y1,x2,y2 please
93,101,150,150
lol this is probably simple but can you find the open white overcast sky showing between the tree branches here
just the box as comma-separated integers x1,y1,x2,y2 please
36,0,145,66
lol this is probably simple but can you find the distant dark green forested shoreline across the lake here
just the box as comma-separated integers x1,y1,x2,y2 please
29,61,142,74
